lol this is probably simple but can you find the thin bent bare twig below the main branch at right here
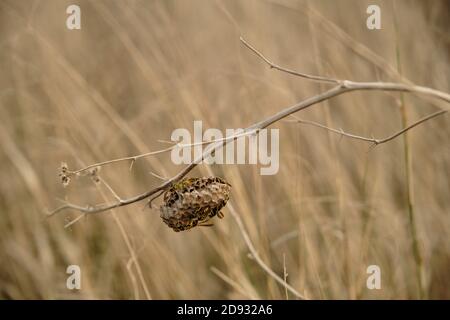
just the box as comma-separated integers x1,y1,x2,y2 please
285,110,447,146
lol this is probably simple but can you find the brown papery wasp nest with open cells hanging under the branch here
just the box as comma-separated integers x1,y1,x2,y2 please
160,177,231,232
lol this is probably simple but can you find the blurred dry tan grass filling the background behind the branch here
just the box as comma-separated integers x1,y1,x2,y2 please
0,0,450,299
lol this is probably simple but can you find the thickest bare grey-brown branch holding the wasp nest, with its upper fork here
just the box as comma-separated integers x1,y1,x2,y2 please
48,38,450,216
